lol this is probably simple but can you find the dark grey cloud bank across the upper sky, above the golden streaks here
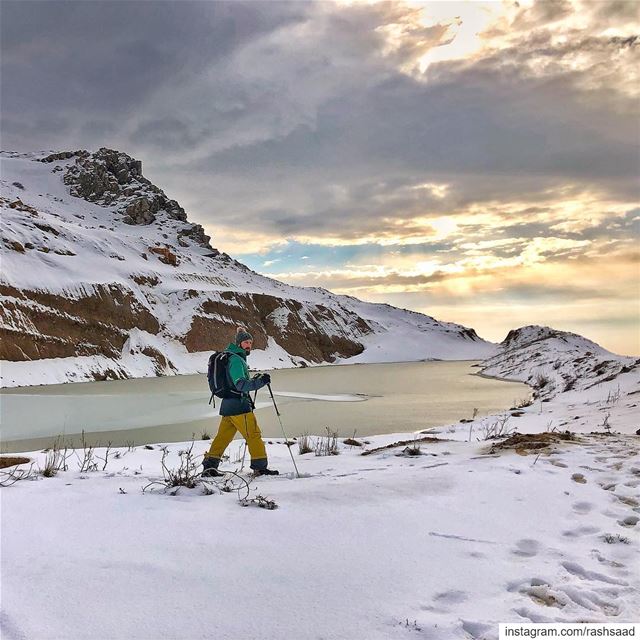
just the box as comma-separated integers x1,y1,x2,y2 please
0,0,638,245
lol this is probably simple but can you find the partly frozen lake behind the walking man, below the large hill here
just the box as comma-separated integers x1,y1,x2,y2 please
0,360,529,453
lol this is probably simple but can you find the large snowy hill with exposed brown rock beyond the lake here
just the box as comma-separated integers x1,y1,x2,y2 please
0,149,497,386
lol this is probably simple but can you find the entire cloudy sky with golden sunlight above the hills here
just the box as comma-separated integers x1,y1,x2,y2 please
0,0,640,355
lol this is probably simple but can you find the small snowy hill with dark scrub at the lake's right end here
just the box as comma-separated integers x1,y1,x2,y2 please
440,326,640,440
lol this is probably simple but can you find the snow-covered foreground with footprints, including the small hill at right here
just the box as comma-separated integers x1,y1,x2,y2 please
0,327,640,640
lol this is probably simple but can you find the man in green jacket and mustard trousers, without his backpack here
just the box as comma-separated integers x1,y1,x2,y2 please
202,327,278,476
